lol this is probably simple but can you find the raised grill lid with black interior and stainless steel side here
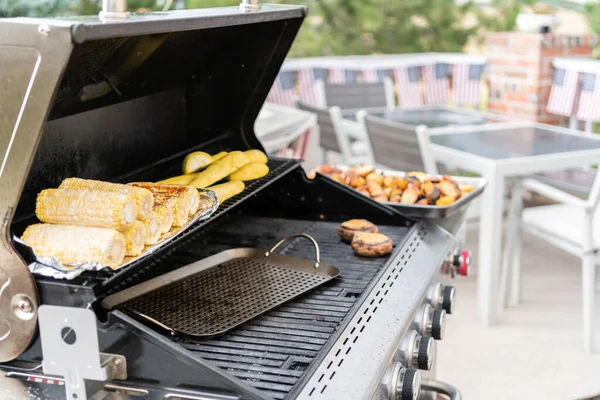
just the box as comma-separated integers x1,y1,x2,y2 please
0,0,306,362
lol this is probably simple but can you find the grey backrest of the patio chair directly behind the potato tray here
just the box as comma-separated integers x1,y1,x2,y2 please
356,110,438,175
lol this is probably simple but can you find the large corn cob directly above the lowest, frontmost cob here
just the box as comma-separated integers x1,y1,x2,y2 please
35,189,137,231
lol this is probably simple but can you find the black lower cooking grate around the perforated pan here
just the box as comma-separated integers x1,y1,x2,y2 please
154,217,409,399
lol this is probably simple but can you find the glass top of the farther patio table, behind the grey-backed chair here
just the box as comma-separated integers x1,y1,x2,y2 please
345,107,501,128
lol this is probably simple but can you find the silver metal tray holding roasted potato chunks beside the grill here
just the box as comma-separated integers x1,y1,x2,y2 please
319,168,487,220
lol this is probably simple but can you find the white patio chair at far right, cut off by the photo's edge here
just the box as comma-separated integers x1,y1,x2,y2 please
500,174,600,352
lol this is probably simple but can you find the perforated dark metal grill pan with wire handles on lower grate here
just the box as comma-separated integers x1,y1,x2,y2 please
102,233,340,338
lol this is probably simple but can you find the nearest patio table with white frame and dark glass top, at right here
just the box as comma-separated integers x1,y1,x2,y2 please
430,122,600,326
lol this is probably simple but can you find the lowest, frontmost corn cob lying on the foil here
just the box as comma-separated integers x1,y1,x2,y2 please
21,224,126,268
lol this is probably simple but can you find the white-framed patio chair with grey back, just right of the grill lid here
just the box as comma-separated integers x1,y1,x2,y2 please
298,101,372,165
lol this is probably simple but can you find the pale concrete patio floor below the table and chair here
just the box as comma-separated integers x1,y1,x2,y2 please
437,228,600,400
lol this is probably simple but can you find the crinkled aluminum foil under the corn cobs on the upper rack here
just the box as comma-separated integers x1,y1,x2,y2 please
25,189,219,280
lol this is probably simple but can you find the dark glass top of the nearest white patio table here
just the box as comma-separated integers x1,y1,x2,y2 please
431,126,600,160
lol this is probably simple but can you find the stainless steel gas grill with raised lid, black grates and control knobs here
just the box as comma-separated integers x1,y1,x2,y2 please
0,1,468,399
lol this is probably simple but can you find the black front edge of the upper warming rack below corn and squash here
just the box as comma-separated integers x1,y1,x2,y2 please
95,158,300,296
